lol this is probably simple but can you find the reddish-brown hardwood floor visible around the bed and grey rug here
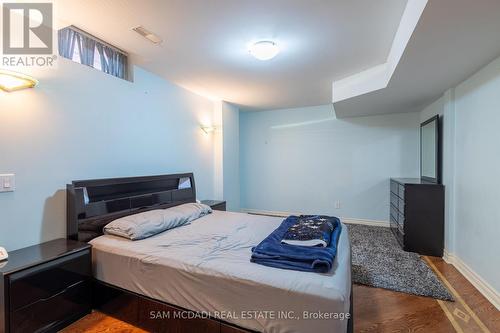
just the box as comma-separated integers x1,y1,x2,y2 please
63,257,500,333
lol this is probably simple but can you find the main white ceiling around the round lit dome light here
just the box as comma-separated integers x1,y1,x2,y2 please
55,0,406,110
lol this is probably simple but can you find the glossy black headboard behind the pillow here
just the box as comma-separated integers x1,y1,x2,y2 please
66,173,196,242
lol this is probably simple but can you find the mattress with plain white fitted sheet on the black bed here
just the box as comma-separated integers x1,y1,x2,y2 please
91,211,351,333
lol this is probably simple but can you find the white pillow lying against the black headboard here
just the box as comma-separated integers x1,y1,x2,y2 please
104,203,212,240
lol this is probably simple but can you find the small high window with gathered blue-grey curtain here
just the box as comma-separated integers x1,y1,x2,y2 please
58,26,127,80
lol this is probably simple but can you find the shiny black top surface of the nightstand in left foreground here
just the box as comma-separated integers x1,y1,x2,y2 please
0,238,90,275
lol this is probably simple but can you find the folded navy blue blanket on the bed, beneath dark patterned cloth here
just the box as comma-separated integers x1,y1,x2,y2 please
250,215,342,273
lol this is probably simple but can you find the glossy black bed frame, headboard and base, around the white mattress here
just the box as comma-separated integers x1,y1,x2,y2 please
66,173,353,333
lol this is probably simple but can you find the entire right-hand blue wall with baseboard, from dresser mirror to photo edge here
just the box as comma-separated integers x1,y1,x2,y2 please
421,58,500,309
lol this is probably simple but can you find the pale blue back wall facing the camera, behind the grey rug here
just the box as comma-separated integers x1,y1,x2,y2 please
240,105,420,221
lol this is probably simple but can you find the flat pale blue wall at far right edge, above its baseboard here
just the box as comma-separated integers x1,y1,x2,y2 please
454,58,500,298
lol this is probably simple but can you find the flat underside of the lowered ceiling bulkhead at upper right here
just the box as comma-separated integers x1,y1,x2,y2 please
334,0,500,118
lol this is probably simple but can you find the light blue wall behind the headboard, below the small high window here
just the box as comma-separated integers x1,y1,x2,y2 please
0,59,214,250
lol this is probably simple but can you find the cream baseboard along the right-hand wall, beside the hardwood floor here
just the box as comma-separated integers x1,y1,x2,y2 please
443,250,500,310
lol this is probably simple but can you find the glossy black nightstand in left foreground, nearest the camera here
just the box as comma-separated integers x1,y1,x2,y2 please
0,239,92,333
